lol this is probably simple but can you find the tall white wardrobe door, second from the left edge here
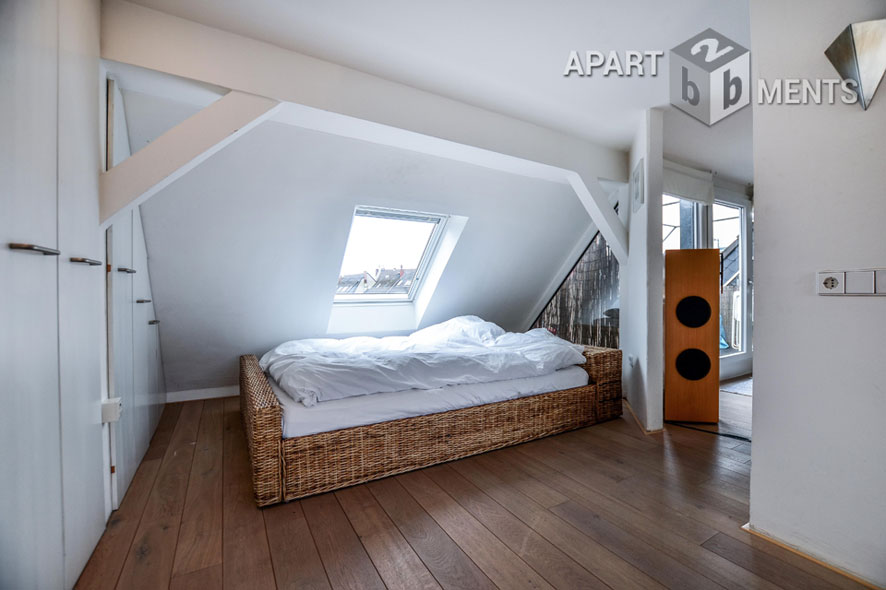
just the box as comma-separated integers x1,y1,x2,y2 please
58,0,105,587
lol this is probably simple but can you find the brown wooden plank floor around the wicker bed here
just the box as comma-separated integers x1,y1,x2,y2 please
77,398,859,590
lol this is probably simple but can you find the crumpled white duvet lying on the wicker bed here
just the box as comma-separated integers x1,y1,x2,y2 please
261,316,585,406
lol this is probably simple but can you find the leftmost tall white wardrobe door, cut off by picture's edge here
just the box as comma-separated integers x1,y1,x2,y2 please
0,0,64,589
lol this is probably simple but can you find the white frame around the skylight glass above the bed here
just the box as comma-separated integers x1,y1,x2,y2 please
332,205,449,305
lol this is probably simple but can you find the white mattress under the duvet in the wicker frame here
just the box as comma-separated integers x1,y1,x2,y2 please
268,366,588,438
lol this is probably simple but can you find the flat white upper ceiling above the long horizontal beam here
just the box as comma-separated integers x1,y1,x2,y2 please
121,0,753,182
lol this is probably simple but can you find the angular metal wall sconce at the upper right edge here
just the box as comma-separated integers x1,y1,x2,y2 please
824,18,886,110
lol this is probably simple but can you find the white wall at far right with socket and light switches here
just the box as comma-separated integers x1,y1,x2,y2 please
751,0,886,586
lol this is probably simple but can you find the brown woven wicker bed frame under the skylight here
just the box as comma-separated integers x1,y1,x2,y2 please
240,347,622,506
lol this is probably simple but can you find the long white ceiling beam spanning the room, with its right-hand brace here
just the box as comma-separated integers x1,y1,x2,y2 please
102,0,629,264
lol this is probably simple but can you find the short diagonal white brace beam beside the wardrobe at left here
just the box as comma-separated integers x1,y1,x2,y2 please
99,90,280,226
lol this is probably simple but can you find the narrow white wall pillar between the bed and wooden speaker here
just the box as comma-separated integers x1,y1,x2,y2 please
619,109,664,430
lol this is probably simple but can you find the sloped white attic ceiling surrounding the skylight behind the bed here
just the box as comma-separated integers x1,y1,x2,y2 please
141,122,591,391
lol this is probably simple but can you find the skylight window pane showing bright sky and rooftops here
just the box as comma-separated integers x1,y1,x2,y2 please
335,207,446,303
